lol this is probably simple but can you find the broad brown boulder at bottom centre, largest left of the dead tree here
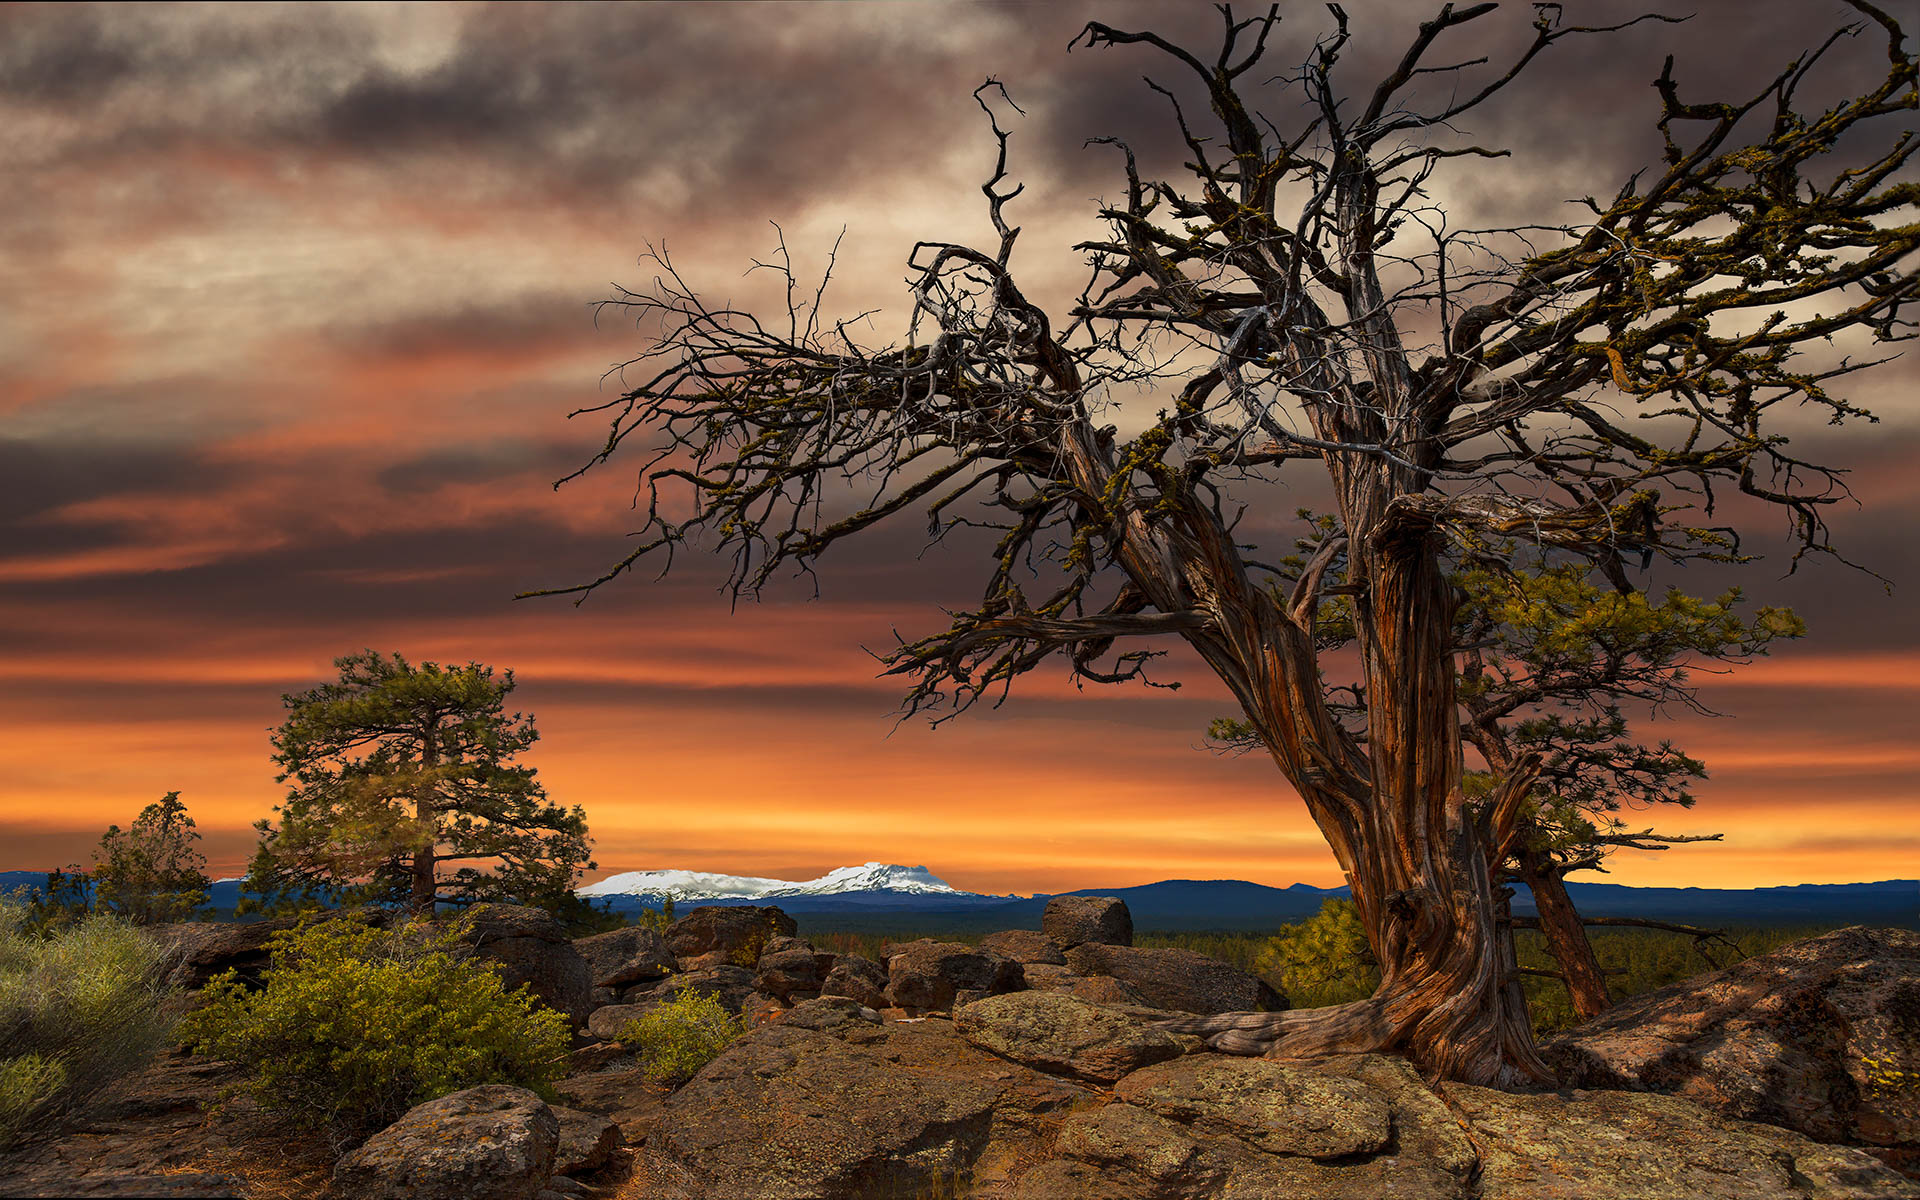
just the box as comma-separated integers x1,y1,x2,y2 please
636,998,1092,1200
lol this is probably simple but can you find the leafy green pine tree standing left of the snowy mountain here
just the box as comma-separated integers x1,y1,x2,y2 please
246,651,593,912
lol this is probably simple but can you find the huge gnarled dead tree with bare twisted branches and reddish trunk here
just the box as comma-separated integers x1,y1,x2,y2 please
529,0,1920,1083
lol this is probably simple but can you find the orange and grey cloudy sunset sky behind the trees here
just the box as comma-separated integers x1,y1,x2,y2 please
0,0,1920,893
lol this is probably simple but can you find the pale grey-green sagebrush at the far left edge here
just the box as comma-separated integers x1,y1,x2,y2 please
0,897,171,1148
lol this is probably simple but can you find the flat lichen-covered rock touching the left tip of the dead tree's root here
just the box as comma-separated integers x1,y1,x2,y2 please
954,991,1183,1083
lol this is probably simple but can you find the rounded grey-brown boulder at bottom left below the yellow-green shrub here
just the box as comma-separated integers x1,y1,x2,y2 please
334,1083,561,1200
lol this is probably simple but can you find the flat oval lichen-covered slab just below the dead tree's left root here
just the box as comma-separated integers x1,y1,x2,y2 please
1114,1054,1394,1158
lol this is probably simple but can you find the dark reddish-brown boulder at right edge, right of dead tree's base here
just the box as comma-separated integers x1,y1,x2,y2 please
1546,927,1920,1162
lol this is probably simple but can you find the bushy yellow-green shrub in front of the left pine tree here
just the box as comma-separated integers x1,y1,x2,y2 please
182,918,570,1137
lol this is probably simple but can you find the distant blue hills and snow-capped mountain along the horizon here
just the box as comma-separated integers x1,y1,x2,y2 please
0,862,1920,931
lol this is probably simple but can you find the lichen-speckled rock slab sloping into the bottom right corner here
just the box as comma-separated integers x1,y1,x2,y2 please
1444,1083,1920,1200
